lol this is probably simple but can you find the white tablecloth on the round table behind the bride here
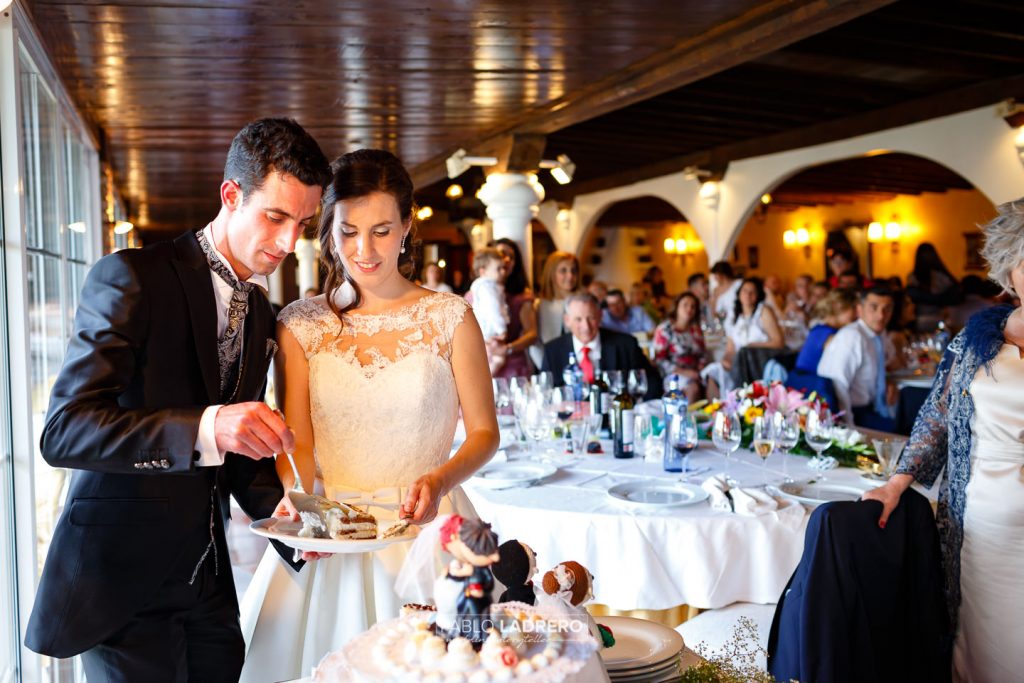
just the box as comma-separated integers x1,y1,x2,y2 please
464,443,921,609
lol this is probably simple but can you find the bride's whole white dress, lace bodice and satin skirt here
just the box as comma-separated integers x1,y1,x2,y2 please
241,293,472,683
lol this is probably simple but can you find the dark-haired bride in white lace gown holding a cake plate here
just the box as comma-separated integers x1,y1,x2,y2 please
241,150,498,682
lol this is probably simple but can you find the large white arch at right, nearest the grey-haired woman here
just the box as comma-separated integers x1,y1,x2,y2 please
706,105,1024,260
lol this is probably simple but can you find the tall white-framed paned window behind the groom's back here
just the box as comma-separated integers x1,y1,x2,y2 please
7,41,100,683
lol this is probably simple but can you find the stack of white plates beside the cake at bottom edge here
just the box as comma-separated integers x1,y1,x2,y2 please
597,616,683,683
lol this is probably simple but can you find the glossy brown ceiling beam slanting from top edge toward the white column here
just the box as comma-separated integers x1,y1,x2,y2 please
412,0,893,186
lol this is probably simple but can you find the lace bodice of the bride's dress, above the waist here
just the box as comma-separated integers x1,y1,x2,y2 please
279,293,469,492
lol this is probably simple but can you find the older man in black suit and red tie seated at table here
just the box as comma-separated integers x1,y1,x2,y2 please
541,292,662,400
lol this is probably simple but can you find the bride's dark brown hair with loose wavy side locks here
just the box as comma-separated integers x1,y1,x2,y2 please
317,150,420,319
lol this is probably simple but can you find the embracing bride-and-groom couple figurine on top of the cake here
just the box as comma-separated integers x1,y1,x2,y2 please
434,515,499,648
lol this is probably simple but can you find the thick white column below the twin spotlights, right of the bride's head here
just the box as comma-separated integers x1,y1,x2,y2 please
478,173,544,280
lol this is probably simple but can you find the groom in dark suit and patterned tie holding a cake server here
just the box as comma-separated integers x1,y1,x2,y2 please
26,119,331,683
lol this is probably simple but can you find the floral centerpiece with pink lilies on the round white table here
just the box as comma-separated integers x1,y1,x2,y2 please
694,381,874,467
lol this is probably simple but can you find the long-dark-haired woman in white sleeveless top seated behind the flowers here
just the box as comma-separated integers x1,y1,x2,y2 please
700,278,785,397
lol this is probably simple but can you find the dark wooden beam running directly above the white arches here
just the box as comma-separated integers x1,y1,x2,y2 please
551,74,1024,201
